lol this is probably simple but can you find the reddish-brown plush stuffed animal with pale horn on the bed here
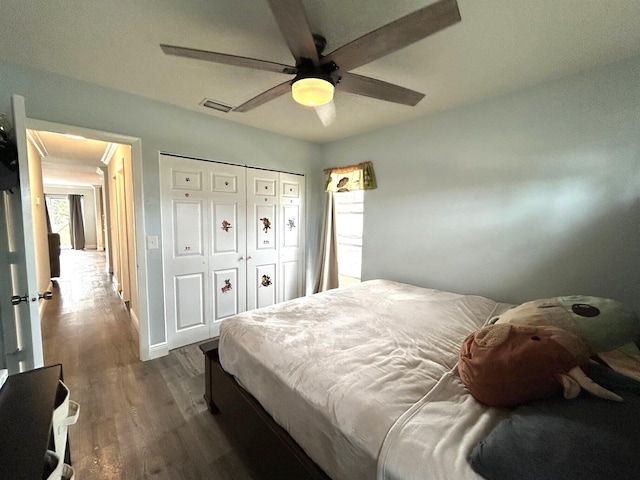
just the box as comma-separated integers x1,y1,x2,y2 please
458,323,622,407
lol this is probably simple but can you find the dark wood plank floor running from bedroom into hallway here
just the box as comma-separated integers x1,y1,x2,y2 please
42,250,259,480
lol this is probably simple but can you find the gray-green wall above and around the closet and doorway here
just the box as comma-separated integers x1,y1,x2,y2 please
0,62,322,345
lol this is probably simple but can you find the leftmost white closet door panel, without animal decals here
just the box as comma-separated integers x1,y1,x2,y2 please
160,155,211,349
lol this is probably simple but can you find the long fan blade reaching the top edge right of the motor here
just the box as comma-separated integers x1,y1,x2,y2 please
322,0,460,71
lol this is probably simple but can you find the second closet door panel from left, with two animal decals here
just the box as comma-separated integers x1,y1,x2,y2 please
208,163,247,337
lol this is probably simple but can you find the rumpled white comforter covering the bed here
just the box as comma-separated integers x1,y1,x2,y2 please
220,280,504,480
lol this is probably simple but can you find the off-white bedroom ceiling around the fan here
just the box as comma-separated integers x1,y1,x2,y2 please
0,0,640,184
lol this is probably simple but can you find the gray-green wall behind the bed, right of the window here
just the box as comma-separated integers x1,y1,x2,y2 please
323,57,640,310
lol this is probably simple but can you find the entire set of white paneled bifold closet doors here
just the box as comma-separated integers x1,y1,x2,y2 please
160,155,305,349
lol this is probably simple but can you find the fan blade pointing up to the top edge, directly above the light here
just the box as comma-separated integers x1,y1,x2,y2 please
267,0,318,65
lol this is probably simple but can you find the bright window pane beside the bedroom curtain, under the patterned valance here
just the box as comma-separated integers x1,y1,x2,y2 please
334,190,364,287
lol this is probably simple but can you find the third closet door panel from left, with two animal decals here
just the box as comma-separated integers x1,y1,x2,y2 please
247,168,281,310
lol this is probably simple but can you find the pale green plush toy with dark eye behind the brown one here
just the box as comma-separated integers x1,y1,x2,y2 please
490,295,640,354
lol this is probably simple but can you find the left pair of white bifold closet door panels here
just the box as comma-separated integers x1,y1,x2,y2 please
160,154,249,349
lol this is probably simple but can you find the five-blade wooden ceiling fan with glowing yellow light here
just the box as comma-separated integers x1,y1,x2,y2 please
160,0,460,119
